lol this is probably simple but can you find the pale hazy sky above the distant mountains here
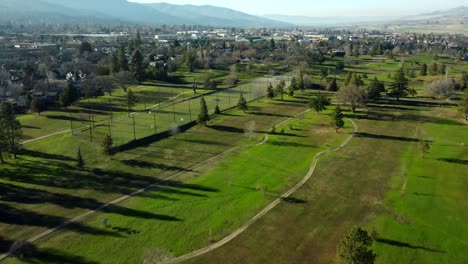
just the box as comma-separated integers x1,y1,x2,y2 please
129,0,468,16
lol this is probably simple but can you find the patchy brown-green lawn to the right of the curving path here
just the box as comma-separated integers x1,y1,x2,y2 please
187,100,468,263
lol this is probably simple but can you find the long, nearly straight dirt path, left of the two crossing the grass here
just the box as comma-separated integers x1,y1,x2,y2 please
0,109,310,261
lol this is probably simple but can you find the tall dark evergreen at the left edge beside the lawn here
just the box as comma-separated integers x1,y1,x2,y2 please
0,103,23,158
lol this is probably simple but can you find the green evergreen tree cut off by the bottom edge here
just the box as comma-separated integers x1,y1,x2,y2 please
338,227,376,264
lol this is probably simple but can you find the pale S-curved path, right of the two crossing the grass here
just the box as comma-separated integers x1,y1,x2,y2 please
167,119,357,264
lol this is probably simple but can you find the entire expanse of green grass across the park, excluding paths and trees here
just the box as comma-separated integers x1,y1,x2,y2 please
0,55,468,263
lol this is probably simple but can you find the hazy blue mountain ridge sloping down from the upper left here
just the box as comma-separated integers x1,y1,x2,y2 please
0,0,290,27
